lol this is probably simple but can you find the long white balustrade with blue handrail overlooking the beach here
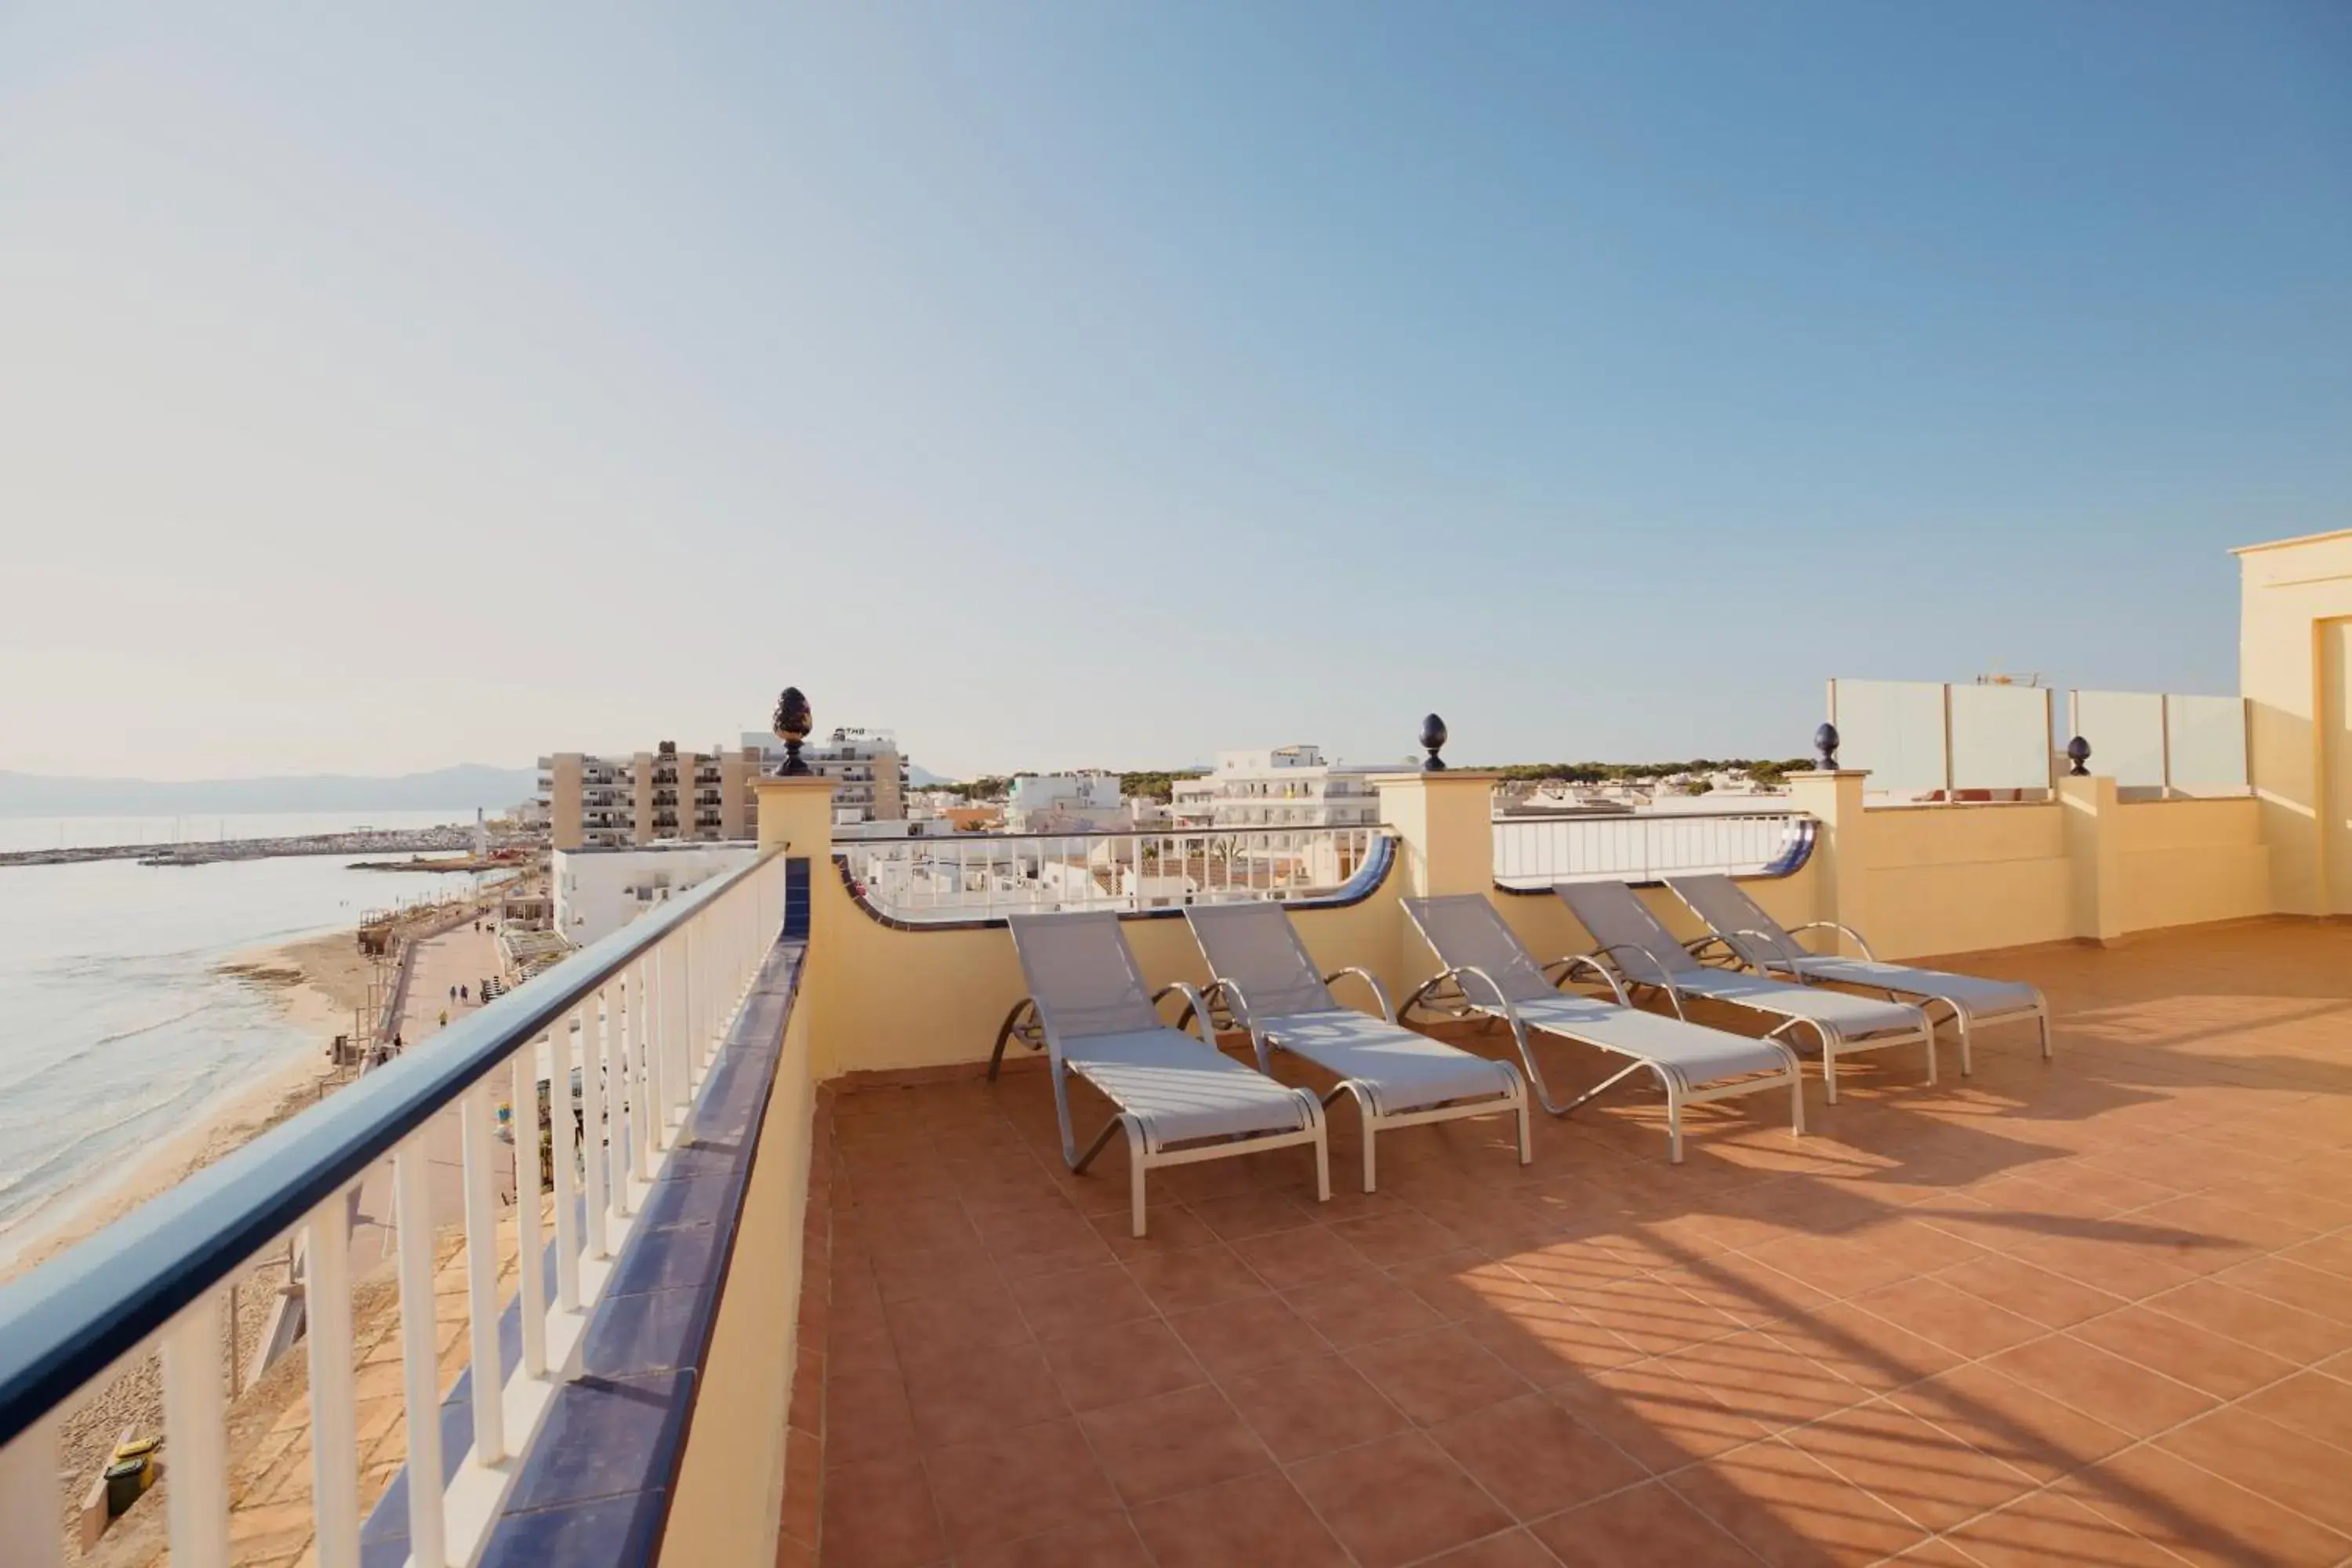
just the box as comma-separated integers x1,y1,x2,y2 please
0,855,786,1568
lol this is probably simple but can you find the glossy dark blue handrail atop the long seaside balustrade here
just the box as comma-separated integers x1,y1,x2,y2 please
0,855,783,1446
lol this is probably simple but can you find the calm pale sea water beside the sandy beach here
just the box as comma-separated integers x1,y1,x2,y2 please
0,811,489,1260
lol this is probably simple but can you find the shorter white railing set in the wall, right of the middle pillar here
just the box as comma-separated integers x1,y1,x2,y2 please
1494,811,1816,888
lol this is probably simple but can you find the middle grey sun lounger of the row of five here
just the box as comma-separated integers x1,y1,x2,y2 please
1404,893,1804,1166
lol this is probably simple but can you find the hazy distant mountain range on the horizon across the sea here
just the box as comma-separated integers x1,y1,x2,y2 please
0,762,539,815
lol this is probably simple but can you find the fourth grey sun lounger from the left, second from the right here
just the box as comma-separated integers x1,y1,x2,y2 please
1552,881,1936,1105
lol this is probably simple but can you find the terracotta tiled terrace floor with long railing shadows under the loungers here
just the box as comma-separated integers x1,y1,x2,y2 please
783,924,2352,1568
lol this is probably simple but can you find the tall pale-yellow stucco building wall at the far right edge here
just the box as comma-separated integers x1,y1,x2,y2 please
2237,529,2352,914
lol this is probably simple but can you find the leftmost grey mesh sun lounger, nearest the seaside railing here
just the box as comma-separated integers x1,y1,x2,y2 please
988,912,1331,1236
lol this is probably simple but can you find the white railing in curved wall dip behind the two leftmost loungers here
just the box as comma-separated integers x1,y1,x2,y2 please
835,825,1390,924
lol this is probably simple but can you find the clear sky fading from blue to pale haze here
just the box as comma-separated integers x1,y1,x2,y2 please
0,0,2352,776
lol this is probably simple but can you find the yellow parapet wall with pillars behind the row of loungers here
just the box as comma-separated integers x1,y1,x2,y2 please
760,774,2270,1079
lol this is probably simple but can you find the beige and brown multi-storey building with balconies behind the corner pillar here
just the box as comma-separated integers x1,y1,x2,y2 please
534,729,906,848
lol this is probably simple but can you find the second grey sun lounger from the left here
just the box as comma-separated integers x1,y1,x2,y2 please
1185,902,1531,1192
